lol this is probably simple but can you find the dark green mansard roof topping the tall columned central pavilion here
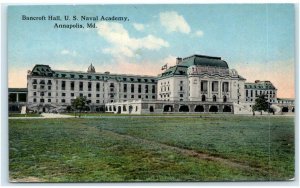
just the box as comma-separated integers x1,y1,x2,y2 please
180,54,228,69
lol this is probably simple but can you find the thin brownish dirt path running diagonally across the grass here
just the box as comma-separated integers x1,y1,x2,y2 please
102,129,269,176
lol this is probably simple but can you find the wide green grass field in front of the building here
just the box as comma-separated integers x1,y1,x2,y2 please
9,116,295,182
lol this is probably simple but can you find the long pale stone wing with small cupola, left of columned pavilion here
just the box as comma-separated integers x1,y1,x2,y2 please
27,64,156,112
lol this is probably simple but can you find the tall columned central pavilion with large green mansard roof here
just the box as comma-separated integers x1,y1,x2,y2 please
157,55,246,103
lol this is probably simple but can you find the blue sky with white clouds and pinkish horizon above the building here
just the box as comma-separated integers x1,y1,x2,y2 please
7,4,295,98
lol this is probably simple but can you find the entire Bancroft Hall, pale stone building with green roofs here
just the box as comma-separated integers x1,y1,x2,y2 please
10,55,294,114
